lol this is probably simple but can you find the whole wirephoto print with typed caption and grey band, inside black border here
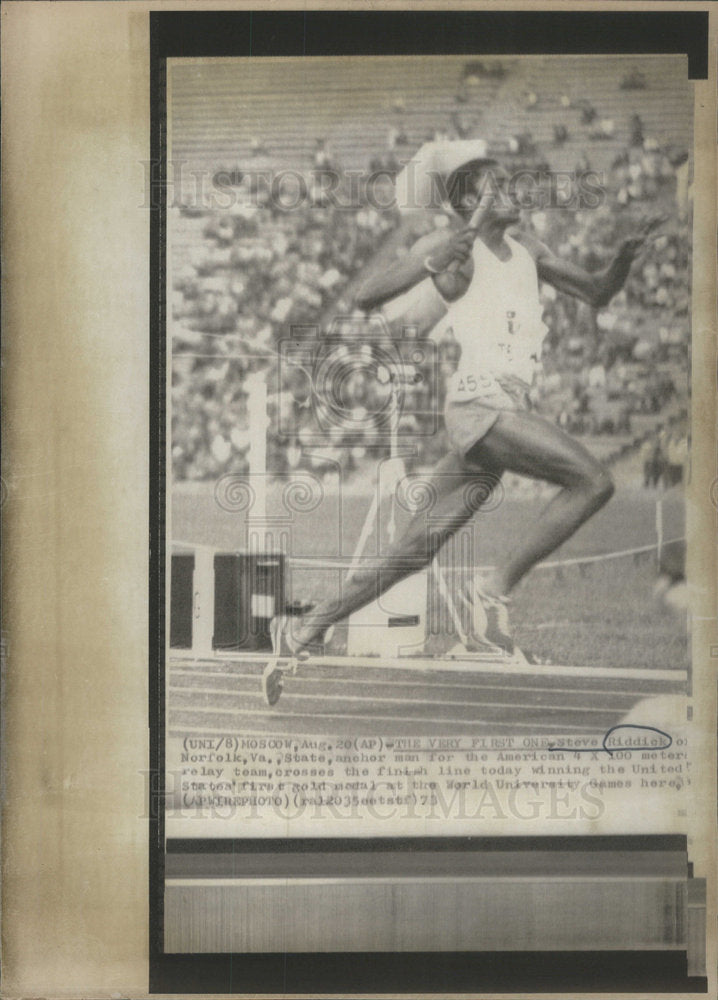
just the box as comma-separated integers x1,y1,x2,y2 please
164,31,705,976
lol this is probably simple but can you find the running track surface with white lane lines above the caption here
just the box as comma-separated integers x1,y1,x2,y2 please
168,657,685,742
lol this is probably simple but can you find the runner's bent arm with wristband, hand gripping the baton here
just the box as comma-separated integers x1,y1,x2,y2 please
356,226,476,312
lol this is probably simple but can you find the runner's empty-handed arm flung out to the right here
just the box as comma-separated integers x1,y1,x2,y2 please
515,216,665,309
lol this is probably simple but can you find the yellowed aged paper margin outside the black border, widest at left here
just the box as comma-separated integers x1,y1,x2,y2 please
2,0,718,997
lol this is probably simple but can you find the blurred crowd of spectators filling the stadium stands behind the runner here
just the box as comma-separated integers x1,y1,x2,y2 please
169,59,691,488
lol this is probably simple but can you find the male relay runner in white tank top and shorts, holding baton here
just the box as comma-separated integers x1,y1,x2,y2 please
263,159,663,704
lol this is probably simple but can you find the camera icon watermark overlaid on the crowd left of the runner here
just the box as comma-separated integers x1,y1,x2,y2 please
279,315,440,446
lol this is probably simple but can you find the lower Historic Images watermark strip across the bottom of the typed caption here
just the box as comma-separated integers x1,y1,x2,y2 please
145,763,622,824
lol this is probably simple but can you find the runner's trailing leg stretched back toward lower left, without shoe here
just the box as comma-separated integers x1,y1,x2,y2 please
293,454,490,648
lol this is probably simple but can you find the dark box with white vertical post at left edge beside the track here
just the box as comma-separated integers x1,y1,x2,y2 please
170,546,285,656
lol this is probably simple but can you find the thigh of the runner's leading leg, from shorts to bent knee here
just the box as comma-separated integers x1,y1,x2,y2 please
469,411,602,486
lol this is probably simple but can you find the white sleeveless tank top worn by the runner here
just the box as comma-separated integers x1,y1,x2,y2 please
442,236,548,401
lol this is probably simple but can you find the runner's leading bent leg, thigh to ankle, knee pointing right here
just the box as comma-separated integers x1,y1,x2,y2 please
469,412,614,596
